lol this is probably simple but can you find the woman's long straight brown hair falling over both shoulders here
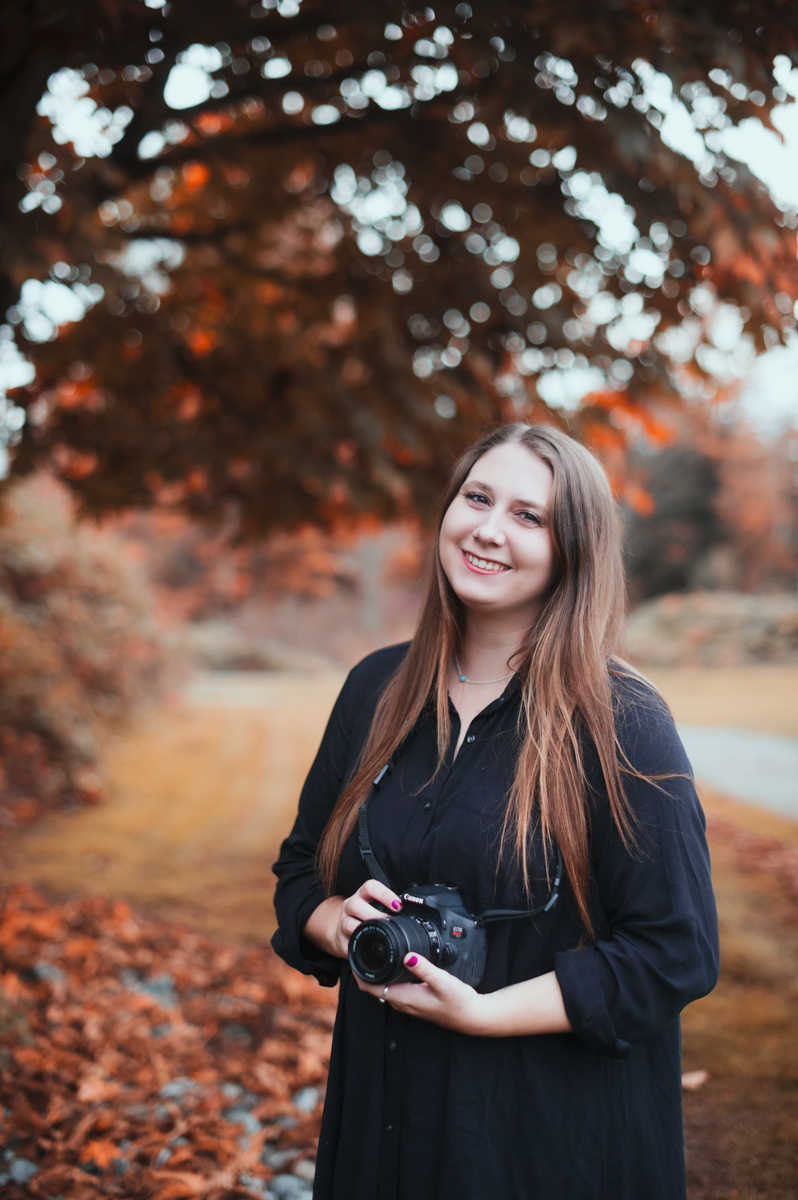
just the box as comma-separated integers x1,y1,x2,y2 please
318,424,637,931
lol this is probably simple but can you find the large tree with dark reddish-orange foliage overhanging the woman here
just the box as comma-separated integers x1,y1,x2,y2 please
0,0,798,533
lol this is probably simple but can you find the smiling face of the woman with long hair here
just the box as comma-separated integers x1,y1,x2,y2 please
439,443,554,624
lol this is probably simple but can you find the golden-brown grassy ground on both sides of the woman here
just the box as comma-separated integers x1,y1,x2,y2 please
2,667,798,1200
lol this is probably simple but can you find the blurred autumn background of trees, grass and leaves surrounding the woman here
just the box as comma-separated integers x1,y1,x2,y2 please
0,7,798,1200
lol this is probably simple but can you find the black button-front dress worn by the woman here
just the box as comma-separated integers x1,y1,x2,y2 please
272,646,719,1200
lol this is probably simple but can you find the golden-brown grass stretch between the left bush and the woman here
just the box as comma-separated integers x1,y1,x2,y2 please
2,674,342,942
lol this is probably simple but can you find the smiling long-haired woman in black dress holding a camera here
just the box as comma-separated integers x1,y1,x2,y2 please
272,425,718,1200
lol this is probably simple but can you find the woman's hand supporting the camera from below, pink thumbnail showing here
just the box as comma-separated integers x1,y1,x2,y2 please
355,954,491,1034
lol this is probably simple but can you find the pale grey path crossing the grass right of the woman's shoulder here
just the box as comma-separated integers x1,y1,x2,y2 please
679,724,798,820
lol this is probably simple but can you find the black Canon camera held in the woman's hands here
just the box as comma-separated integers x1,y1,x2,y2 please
349,886,487,988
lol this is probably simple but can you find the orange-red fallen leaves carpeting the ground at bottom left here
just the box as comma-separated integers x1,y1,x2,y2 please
0,886,335,1200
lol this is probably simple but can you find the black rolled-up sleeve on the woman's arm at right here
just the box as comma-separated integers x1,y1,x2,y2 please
554,688,720,1058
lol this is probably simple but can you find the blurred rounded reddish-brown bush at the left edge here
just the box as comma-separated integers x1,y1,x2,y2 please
0,479,164,826
